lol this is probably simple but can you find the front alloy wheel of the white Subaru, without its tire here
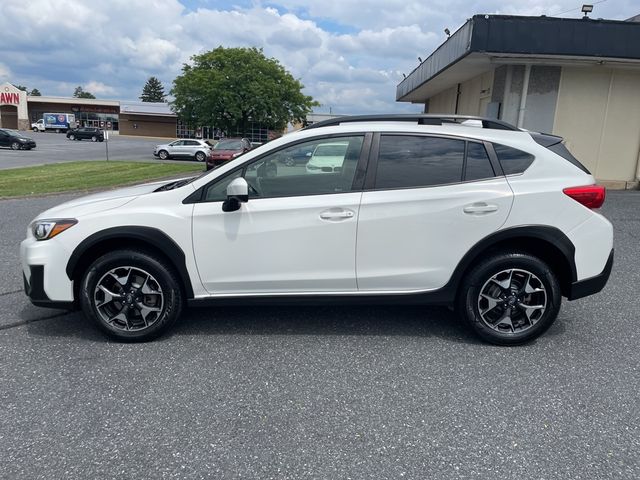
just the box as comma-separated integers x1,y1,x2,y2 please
93,266,165,331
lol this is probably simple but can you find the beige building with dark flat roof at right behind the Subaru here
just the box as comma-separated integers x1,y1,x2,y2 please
396,15,640,188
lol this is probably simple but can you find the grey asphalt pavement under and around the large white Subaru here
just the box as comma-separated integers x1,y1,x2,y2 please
0,189,640,479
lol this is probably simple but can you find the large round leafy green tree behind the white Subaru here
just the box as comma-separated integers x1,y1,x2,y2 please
171,47,319,135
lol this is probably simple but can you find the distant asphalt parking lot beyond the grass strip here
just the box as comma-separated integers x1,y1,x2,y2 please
0,132,185,170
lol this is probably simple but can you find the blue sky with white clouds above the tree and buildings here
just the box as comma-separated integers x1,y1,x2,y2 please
0,0,640,114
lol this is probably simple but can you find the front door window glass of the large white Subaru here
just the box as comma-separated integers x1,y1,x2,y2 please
204,136,364,201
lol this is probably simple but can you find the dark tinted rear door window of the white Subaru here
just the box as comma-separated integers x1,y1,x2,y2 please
375,135,464,188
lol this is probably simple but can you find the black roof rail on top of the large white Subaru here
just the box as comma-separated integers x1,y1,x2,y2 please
303,113,520,131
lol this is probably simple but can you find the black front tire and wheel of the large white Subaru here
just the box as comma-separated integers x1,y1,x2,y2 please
80,250,184,342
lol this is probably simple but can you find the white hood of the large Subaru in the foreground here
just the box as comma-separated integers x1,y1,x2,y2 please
37,180,181,218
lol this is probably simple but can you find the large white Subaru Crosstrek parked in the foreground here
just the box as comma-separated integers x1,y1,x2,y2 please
21,115,613,344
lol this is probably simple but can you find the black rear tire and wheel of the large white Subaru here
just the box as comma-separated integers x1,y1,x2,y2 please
458,252,562,345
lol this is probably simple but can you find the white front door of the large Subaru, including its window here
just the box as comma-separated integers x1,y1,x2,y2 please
193,136,364,295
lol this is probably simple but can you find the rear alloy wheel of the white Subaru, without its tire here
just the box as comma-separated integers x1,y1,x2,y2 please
477,268,547,334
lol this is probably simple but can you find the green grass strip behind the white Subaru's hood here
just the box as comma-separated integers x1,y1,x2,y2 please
0,161,204,198
